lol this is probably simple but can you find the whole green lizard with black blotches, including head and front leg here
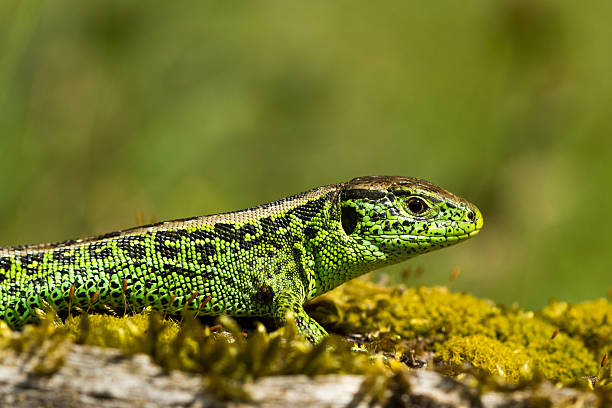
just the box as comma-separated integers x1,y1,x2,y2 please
0,176,483,342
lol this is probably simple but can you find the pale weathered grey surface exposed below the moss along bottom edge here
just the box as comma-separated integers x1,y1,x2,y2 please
0,345,600,408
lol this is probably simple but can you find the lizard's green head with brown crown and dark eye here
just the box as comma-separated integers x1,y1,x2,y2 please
340,176,483,263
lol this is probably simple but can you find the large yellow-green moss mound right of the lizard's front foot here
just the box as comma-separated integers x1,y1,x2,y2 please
312,280,598,384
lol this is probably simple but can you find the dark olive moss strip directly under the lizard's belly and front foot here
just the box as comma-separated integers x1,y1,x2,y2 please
0,312,385,399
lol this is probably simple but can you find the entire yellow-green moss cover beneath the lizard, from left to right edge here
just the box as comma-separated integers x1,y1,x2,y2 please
0,280,612,399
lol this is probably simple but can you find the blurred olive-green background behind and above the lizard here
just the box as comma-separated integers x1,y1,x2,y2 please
0,0,612,307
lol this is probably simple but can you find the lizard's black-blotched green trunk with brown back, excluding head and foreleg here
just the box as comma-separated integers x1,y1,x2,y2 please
0,185,340,327
